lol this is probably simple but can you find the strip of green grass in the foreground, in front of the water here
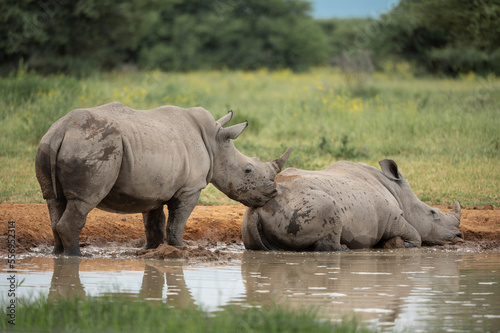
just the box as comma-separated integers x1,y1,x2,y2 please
0,297,370,333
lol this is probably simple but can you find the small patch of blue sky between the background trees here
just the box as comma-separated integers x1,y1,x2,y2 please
309,0,399,18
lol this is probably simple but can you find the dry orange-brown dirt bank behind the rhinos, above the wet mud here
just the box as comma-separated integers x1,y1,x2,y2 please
0,203,500,257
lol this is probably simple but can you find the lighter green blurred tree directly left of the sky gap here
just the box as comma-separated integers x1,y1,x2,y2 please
139,0,327,70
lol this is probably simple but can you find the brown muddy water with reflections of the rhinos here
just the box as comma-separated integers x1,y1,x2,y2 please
0,249,500,332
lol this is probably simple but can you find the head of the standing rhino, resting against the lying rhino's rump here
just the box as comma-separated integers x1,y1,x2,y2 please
211,111,292,207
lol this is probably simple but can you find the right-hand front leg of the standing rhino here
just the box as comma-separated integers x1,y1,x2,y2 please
167,191,201,247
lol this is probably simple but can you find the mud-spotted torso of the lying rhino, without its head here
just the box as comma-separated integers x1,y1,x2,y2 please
259,162,399,248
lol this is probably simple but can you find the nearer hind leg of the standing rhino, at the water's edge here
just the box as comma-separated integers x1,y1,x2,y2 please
55,199,94,256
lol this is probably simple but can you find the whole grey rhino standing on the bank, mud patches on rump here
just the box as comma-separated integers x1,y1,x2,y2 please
35,103,290,255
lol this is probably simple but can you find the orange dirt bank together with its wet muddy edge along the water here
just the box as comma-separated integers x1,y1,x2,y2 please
0,203,500,264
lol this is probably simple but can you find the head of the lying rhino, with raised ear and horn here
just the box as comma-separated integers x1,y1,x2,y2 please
379,159,463,245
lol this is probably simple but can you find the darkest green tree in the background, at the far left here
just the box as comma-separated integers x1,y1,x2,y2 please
0,0,154,73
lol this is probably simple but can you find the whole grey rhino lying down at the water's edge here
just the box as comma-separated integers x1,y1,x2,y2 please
242,160,463,251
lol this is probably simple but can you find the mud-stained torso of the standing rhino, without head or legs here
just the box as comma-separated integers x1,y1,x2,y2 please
52,103,215,212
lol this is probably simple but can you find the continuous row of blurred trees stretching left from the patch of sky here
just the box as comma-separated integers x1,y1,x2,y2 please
0,0,332,75
